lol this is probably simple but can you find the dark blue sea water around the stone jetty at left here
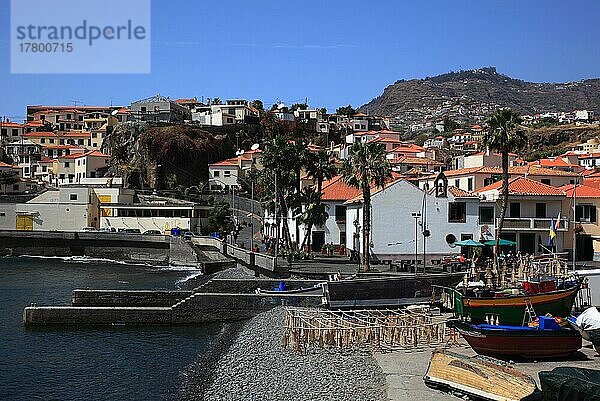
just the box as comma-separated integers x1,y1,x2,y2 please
0,257,224,400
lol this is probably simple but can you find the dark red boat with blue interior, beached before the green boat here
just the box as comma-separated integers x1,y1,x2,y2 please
448,316,582,359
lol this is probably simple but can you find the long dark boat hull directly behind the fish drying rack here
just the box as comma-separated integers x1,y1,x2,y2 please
323,273,463,308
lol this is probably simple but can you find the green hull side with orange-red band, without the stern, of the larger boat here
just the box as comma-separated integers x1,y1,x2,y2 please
463,285,579,326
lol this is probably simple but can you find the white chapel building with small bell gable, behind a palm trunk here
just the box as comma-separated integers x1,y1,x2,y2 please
345,174,486,260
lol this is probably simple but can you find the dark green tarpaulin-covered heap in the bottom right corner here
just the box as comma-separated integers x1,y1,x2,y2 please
540,367,600,401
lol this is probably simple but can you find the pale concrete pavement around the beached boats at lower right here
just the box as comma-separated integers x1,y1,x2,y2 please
374,338,600,401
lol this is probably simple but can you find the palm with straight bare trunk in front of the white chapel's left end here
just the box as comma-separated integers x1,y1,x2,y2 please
342,142,392,272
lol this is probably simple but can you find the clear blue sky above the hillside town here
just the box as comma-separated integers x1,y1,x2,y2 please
0,0,600,120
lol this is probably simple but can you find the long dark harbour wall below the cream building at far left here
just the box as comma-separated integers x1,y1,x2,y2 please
0,230,220,265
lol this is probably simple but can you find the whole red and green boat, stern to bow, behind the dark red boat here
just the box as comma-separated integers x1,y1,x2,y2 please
437,281,580,325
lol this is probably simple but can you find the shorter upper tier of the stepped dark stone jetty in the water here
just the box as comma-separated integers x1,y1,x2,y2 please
71,290,193,307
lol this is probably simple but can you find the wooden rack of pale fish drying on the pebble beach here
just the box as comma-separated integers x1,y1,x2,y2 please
282,307,453,353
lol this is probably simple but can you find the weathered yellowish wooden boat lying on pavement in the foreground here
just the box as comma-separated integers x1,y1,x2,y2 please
423,350,537,401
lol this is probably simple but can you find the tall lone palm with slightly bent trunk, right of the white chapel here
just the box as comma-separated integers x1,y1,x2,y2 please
483,108,527,271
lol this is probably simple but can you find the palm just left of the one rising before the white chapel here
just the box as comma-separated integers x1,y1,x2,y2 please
301,149,337,252
